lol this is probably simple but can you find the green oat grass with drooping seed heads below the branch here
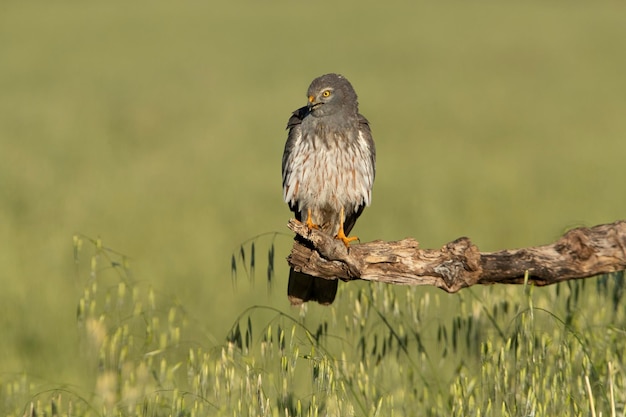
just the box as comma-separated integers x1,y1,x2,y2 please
0,238,626,416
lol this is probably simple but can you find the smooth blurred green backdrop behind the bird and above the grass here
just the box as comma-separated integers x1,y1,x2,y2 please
0,0,626,394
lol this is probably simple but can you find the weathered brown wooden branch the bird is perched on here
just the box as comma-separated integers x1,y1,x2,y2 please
287,220,626,293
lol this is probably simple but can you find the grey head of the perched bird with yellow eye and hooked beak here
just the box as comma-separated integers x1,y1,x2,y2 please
307,74,358,117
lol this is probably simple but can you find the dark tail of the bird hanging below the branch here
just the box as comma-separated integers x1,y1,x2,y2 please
287,268,339,305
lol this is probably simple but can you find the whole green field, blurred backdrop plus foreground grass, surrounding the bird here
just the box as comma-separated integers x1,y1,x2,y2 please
0,0,626,416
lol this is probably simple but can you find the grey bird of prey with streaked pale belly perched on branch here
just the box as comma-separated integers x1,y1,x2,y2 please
282,73,376,305
